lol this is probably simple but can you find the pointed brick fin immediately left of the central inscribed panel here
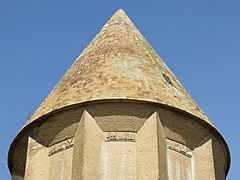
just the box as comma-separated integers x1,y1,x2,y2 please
72,111,104,180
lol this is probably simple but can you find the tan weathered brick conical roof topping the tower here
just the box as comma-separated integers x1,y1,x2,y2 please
27,9,211,124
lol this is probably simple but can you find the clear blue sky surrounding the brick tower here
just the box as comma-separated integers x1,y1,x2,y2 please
0,0,240,180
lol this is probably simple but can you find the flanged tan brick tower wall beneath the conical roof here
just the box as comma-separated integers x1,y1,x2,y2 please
11,102,229,180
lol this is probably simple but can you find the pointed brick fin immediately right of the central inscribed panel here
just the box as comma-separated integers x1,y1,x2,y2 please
137,112,168,180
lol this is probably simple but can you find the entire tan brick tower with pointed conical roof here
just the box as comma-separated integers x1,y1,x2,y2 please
8,10,230,180
